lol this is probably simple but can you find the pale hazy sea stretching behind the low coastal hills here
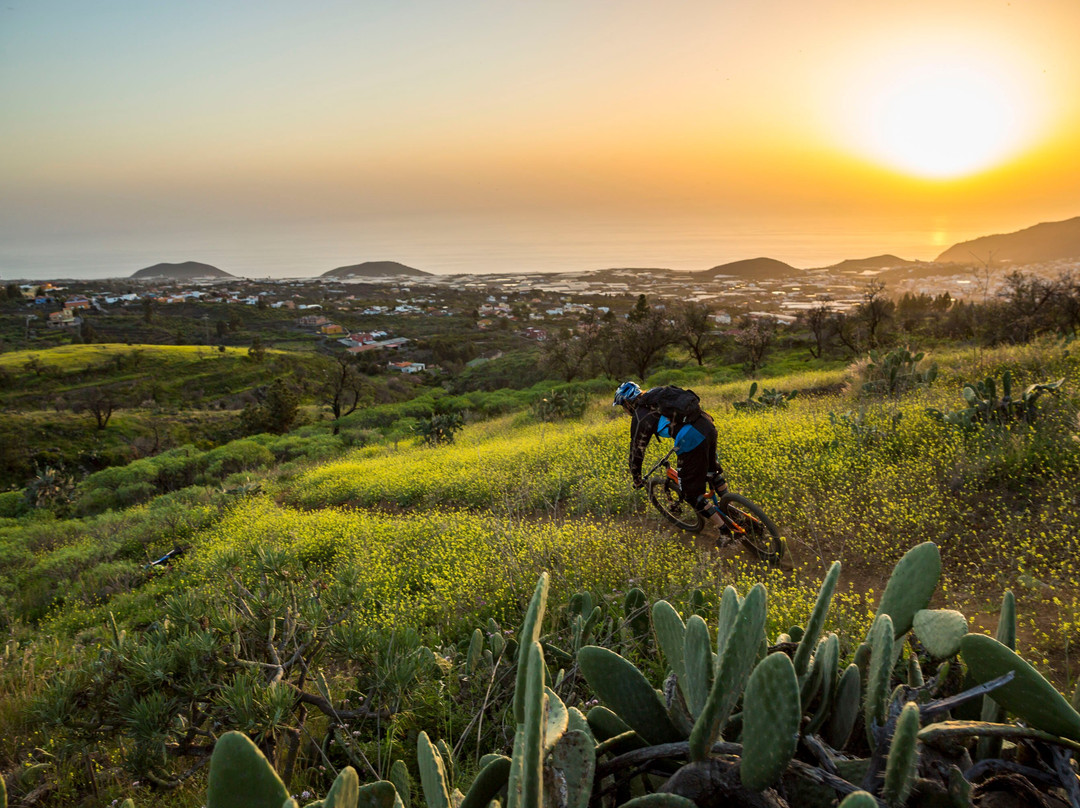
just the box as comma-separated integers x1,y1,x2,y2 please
0,209,1019,282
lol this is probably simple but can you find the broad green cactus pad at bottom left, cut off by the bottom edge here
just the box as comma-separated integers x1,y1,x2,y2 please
206,732,289,808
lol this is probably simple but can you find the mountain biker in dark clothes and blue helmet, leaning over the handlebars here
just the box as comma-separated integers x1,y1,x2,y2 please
611,381,728,542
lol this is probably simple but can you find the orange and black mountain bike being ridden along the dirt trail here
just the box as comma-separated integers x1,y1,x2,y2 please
645,449,784,566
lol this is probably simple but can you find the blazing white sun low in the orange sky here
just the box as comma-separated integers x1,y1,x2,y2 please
845,43,1040,179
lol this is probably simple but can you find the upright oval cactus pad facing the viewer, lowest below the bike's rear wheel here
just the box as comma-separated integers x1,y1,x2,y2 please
739,654,802,791
